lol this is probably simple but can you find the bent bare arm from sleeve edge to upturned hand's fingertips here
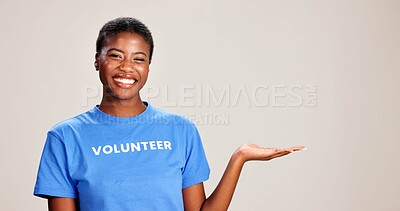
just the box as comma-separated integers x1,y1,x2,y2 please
183,144,304,211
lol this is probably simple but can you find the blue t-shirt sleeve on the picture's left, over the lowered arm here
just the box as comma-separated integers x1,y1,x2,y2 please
33,131,77,198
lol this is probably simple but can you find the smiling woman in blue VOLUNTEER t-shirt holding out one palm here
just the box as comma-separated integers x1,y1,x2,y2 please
34,18,304,211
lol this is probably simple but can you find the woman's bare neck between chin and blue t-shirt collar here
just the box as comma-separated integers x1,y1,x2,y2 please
99,96,146,117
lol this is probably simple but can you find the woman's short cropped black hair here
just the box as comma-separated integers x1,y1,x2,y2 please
96,17,154,61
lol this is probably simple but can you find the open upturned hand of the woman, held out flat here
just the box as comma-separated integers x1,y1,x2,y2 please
236,144,305,162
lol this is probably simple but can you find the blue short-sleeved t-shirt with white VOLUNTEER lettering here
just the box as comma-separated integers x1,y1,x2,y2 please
34,103,210,211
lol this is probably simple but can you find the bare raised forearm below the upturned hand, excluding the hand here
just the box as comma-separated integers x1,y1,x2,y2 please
201,151,245,211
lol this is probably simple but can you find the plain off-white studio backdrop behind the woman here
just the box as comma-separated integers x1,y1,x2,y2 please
0,0,400,211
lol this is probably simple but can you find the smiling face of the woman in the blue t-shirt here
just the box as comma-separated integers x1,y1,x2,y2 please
95,32,150,102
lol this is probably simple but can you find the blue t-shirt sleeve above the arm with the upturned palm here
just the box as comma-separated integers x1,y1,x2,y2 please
182,125,210,188
